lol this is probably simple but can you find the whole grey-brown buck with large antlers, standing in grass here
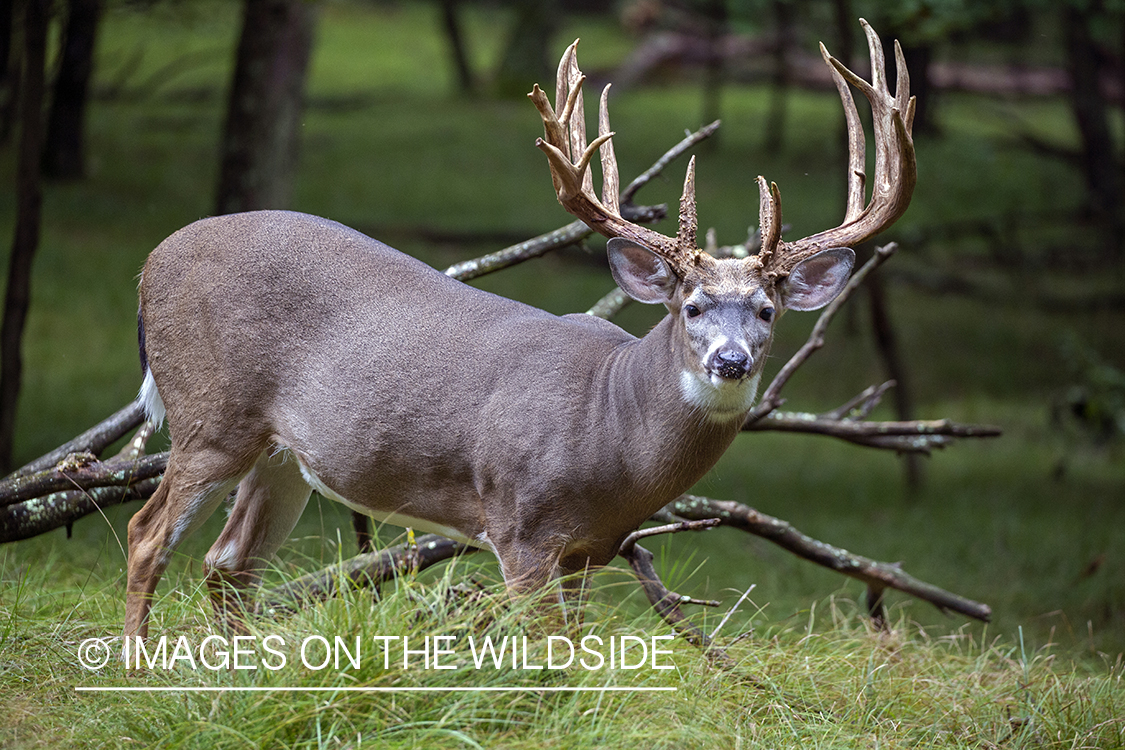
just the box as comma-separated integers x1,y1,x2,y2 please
125,20,917,638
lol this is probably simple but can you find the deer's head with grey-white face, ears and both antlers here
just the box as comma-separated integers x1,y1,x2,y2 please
528,19,917,415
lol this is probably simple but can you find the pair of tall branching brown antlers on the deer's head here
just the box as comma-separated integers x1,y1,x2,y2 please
540,24,917,287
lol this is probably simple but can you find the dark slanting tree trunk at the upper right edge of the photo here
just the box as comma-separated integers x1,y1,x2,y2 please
1062,3,1125,256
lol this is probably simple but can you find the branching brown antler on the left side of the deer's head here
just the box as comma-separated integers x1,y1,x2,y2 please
528,39,702,277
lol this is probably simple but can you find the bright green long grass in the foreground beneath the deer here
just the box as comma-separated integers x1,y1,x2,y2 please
0,546,1125,748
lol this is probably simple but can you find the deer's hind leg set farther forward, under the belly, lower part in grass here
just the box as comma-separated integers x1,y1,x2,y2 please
204,446,312,631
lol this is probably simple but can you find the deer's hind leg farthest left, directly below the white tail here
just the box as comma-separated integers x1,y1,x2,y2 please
125,446,250,638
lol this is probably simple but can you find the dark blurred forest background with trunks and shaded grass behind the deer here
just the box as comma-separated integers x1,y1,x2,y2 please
0,0,1125,661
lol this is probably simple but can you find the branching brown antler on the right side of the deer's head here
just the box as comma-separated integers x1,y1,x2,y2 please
758,18,918,278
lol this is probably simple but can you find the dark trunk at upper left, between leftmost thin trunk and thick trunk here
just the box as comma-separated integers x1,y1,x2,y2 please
43,0,101,180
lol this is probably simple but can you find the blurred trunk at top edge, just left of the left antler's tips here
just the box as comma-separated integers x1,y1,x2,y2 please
495,0,559,97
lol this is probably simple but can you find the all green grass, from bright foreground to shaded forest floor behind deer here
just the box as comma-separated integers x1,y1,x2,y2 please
0,2,1125,748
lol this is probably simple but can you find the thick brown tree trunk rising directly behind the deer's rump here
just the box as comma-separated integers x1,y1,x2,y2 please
216,0,315,214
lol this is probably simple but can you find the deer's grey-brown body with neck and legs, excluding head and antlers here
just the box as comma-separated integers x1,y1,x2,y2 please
129,211,756,631
